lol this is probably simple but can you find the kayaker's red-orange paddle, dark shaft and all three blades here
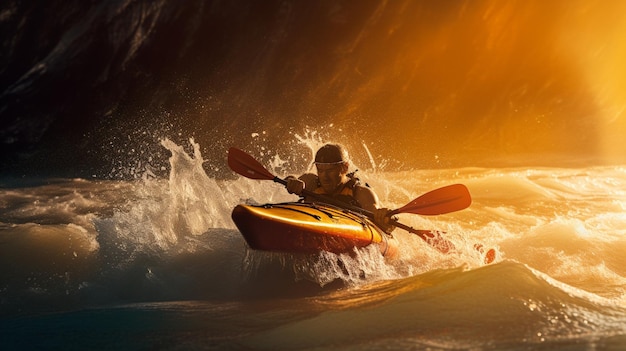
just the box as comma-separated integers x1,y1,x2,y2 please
228,147,472,253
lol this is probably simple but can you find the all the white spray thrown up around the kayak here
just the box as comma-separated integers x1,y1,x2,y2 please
92,130,500,287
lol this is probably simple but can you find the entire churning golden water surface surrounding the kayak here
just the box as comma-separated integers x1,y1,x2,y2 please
0,139,626,350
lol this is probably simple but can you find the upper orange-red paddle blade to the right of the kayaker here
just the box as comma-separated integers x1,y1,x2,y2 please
391,184,472,216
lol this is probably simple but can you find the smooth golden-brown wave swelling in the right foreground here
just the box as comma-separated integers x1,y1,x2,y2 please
246,261,626,349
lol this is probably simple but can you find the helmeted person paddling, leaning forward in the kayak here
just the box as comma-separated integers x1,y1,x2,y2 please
286,144,394,232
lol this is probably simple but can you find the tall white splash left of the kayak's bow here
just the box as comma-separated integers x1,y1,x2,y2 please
101,139,235,250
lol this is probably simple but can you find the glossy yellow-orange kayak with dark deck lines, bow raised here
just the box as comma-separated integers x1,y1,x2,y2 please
232,202,397,257
